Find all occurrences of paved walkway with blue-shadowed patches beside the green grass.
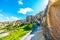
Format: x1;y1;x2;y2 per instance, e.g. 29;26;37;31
21;24;45;40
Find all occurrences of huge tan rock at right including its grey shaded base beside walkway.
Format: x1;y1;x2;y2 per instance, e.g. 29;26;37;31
45;0;60;40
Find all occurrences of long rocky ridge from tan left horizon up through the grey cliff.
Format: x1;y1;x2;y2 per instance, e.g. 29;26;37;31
0;11;44;27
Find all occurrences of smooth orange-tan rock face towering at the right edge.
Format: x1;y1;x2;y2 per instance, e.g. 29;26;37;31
48;0;60;40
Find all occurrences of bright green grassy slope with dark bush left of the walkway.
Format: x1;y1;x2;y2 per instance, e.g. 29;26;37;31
1;24;33;40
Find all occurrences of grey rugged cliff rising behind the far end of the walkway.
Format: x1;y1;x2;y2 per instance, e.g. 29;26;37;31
26;11;44;25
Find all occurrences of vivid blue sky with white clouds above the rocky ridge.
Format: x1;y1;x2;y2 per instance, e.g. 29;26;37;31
0;0;48;22
